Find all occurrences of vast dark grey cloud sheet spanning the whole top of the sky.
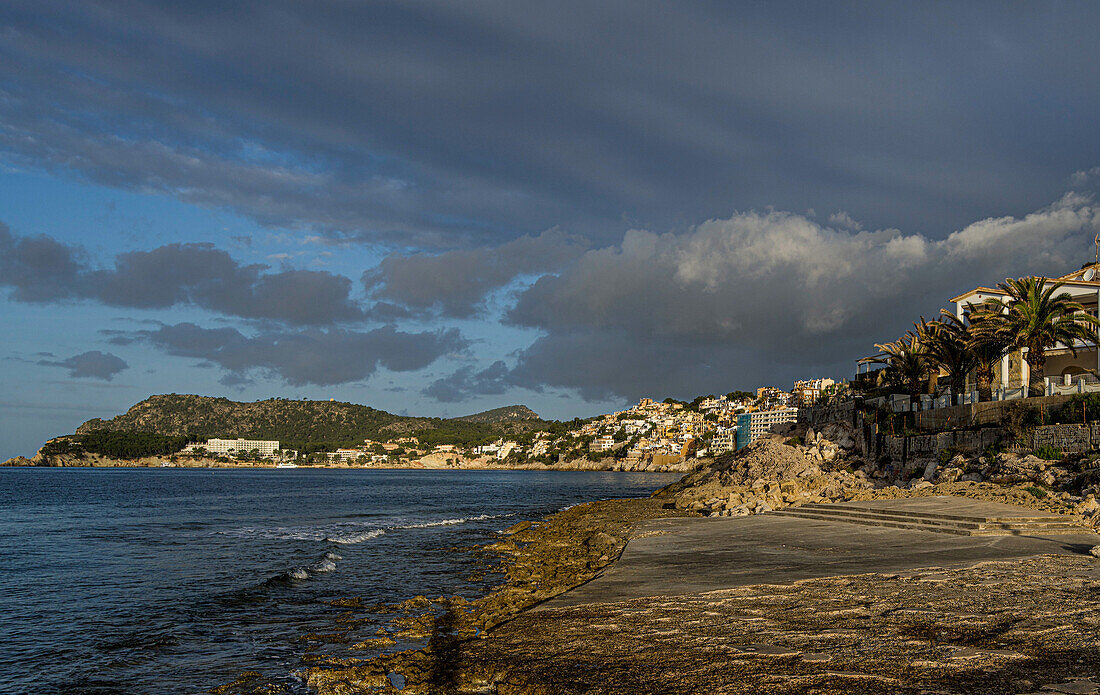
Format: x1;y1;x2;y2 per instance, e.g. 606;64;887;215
0;0;1100;245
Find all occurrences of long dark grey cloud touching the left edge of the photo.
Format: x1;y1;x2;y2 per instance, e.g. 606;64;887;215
0;224;364;326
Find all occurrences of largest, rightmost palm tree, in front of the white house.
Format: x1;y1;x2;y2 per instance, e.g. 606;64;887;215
979;277;1100;396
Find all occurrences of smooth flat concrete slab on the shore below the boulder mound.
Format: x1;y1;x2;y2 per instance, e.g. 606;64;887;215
540;497;1100;609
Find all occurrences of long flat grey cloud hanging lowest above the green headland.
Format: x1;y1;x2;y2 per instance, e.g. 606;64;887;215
134;323;469;386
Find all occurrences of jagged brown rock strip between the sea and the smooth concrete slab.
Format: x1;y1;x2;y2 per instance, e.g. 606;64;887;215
212;498;696;695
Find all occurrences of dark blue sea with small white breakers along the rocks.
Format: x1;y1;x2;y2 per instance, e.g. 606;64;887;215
0;468;679;695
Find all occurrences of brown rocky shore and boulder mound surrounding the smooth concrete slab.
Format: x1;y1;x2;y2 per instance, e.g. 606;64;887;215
236;424;1100;695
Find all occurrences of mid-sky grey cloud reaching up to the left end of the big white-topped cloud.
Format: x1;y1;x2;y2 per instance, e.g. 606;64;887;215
363;230;586;318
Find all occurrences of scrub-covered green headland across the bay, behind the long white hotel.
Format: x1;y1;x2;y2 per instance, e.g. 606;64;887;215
72;394;550;454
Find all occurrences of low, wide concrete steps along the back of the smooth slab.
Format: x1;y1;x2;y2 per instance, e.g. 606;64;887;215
770;505;1089;536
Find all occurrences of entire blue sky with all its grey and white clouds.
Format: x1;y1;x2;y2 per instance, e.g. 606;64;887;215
0;0;1100;457
